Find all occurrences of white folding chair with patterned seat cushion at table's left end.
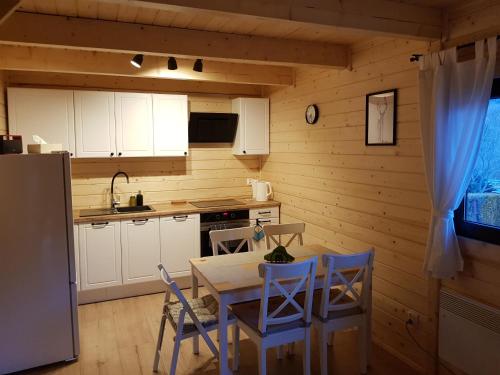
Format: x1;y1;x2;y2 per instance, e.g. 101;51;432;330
153;264;239;375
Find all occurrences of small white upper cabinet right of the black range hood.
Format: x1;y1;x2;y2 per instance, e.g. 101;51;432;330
232;98;269;155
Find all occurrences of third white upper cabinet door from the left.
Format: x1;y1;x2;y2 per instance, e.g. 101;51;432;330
115;92;154;156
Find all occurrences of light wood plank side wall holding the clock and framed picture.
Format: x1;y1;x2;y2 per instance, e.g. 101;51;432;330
261;38;436;372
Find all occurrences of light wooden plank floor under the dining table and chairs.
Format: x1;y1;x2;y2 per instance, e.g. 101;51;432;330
22;291;417;375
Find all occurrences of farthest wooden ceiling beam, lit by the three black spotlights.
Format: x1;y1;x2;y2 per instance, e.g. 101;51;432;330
0;45;294;86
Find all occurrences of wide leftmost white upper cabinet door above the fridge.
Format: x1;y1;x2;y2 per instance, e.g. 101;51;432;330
7;88;75;155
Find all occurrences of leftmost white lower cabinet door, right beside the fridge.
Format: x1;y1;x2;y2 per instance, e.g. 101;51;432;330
78;222;122;290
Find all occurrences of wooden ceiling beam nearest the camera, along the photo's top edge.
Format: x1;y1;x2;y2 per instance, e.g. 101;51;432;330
119;0;442;40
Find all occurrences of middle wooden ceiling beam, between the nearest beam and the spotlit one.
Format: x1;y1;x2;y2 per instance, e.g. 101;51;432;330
0;12;349;68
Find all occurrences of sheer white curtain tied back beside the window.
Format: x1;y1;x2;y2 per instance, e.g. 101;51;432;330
419;38;497;278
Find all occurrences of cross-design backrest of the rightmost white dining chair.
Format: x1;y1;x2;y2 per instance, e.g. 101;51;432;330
320;249;374;319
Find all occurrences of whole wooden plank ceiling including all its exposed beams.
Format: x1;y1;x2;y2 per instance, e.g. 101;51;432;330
0;0;458;85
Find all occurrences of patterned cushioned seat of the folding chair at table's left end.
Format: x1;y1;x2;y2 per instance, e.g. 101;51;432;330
167;295;234;334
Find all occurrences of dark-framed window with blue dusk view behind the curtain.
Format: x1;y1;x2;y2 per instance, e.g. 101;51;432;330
455;79;500;244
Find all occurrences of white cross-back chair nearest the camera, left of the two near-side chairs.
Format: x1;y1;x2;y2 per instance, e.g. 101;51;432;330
230;257;318;375
